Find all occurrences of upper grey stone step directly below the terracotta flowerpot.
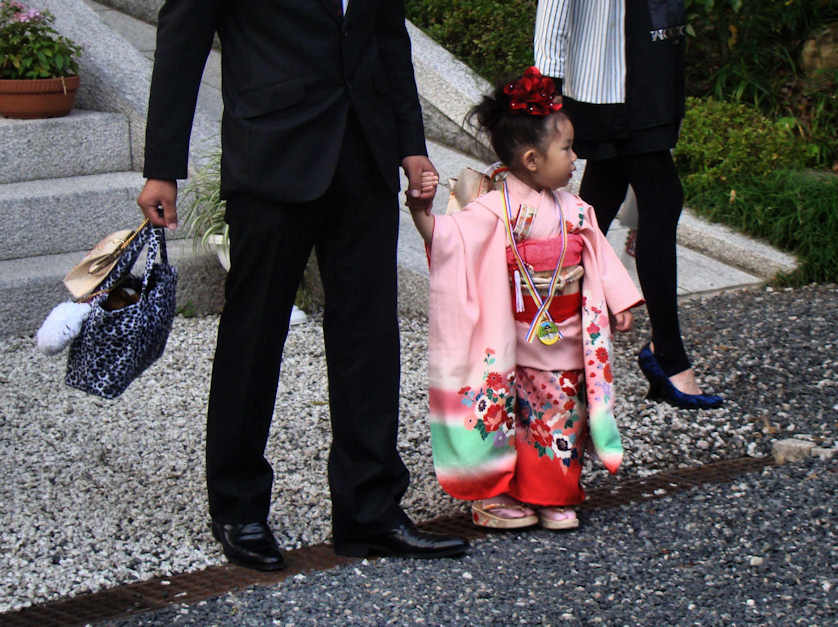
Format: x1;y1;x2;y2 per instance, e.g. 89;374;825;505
0;110;131;184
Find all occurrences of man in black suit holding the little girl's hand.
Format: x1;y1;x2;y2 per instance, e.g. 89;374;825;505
137;0;468;570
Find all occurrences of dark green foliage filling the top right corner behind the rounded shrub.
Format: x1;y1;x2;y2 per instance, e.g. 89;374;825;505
685;0;838;168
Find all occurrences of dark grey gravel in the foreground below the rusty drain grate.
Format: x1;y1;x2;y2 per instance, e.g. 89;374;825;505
108;459;838;626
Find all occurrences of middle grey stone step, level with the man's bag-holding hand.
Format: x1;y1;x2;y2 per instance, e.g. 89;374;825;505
0;172;154;260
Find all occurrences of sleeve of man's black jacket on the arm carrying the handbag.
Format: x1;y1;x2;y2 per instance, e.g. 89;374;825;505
143;0;221;180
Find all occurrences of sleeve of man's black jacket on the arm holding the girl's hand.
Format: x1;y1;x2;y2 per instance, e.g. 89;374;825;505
376;0;428;158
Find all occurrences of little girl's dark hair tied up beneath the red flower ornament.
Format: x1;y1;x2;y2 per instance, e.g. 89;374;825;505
466;74;568;170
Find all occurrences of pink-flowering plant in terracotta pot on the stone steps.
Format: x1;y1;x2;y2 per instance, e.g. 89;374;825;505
0;0;81;118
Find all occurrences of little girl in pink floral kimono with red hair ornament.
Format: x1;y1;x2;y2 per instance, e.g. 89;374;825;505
413;67;643;529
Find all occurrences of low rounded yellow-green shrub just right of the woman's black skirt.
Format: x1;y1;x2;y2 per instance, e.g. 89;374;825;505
674;98;805;186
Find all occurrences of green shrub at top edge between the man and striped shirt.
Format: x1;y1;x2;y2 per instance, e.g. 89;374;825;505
405;0;538;84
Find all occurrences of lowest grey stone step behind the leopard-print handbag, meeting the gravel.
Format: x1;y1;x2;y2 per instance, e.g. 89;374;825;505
0;239;226;337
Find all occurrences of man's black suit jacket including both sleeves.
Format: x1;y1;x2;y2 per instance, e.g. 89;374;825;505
143;0;427;202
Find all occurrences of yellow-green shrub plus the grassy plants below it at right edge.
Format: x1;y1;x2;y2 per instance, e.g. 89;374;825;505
674;98;838;284
